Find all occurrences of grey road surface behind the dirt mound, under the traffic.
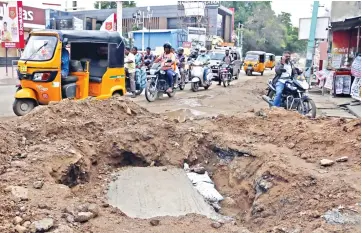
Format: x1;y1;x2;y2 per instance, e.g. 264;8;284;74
0;71;273;117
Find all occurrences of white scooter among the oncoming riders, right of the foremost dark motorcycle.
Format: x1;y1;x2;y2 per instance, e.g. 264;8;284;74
191;61;213;92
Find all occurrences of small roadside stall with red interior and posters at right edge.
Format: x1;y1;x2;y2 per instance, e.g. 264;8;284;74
317;16;361;100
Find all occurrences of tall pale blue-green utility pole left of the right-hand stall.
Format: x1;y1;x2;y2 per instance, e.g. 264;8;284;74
305;1;319;84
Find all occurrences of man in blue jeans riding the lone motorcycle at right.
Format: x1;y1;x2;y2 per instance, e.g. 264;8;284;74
273;51;296;107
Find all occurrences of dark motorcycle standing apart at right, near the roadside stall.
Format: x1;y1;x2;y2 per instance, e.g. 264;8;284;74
262;68;317;118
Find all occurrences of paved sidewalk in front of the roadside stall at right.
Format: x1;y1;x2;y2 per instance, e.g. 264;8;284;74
309;90;361;118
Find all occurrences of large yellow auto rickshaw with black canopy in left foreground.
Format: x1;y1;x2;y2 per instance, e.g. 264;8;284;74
13;30;126;116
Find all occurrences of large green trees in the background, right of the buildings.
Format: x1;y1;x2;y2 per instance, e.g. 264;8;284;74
223;1;307;54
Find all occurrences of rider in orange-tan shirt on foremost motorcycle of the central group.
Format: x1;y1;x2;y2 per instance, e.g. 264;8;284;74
155;43;176;93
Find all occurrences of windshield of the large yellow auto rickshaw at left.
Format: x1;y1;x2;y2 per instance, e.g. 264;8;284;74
20;36;58;61
